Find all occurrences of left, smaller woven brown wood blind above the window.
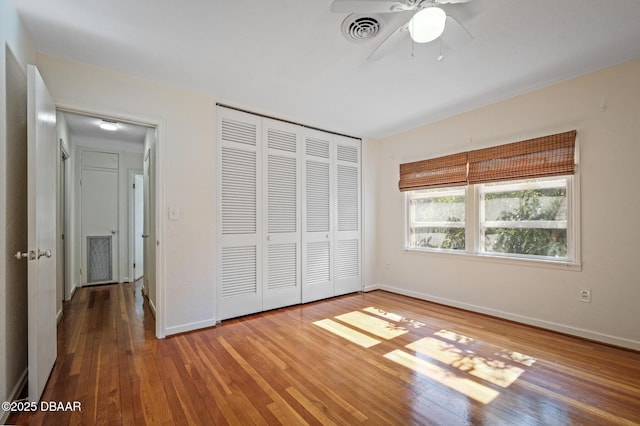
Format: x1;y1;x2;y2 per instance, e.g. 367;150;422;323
398;152;467;191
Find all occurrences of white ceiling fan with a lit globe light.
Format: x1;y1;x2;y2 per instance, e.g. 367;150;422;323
331;0;473;61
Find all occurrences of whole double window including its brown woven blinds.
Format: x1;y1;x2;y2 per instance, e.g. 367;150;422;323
399;131;578;264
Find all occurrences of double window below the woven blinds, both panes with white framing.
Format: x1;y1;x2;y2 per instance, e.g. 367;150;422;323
405;176;575;262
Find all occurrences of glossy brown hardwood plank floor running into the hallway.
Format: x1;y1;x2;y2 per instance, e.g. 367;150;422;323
9;284;640;425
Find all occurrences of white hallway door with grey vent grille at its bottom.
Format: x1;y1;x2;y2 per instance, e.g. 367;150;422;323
80;169;118;285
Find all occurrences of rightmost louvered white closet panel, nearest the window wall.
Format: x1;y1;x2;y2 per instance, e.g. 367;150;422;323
334;136;362;295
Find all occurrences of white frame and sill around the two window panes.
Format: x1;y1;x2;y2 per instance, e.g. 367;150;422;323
403;171;581;270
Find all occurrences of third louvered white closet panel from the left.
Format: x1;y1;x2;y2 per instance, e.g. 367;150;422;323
301;129;335;302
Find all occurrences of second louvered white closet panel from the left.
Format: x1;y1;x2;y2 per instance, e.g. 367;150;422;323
262;119;301;310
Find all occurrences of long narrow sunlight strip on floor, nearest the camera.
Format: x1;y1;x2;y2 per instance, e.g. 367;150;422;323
384;349;500;404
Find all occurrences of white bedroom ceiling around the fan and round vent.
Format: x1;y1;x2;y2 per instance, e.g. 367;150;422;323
13;0;640;138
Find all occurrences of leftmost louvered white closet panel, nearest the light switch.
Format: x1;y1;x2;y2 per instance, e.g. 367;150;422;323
218;108;262;320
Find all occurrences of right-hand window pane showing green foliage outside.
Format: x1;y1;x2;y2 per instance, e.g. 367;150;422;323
480;178;567;258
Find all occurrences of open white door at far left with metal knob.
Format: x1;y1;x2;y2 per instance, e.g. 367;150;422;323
26;65;57;402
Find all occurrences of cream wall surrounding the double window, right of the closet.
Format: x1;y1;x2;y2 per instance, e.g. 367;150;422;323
377;60;640;349
